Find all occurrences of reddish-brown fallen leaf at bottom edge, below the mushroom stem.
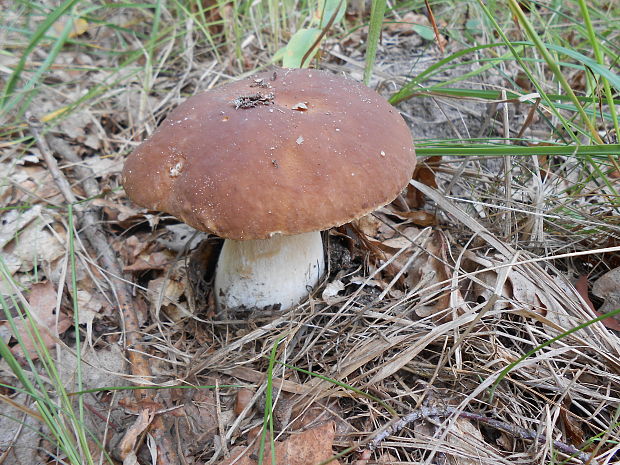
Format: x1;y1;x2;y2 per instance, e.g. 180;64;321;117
219;422;340;465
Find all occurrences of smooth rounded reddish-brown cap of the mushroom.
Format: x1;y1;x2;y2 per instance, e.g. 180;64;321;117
123;69;415;240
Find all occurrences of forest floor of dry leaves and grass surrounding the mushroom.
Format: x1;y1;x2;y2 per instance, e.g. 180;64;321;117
0;1;620;465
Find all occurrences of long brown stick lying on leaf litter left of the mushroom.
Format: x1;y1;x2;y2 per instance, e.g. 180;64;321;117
28;116;178;464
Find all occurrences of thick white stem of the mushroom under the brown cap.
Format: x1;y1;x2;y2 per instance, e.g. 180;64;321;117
215;231;325;310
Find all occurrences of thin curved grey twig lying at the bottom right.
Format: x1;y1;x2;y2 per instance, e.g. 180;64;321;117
367;407;596;465
